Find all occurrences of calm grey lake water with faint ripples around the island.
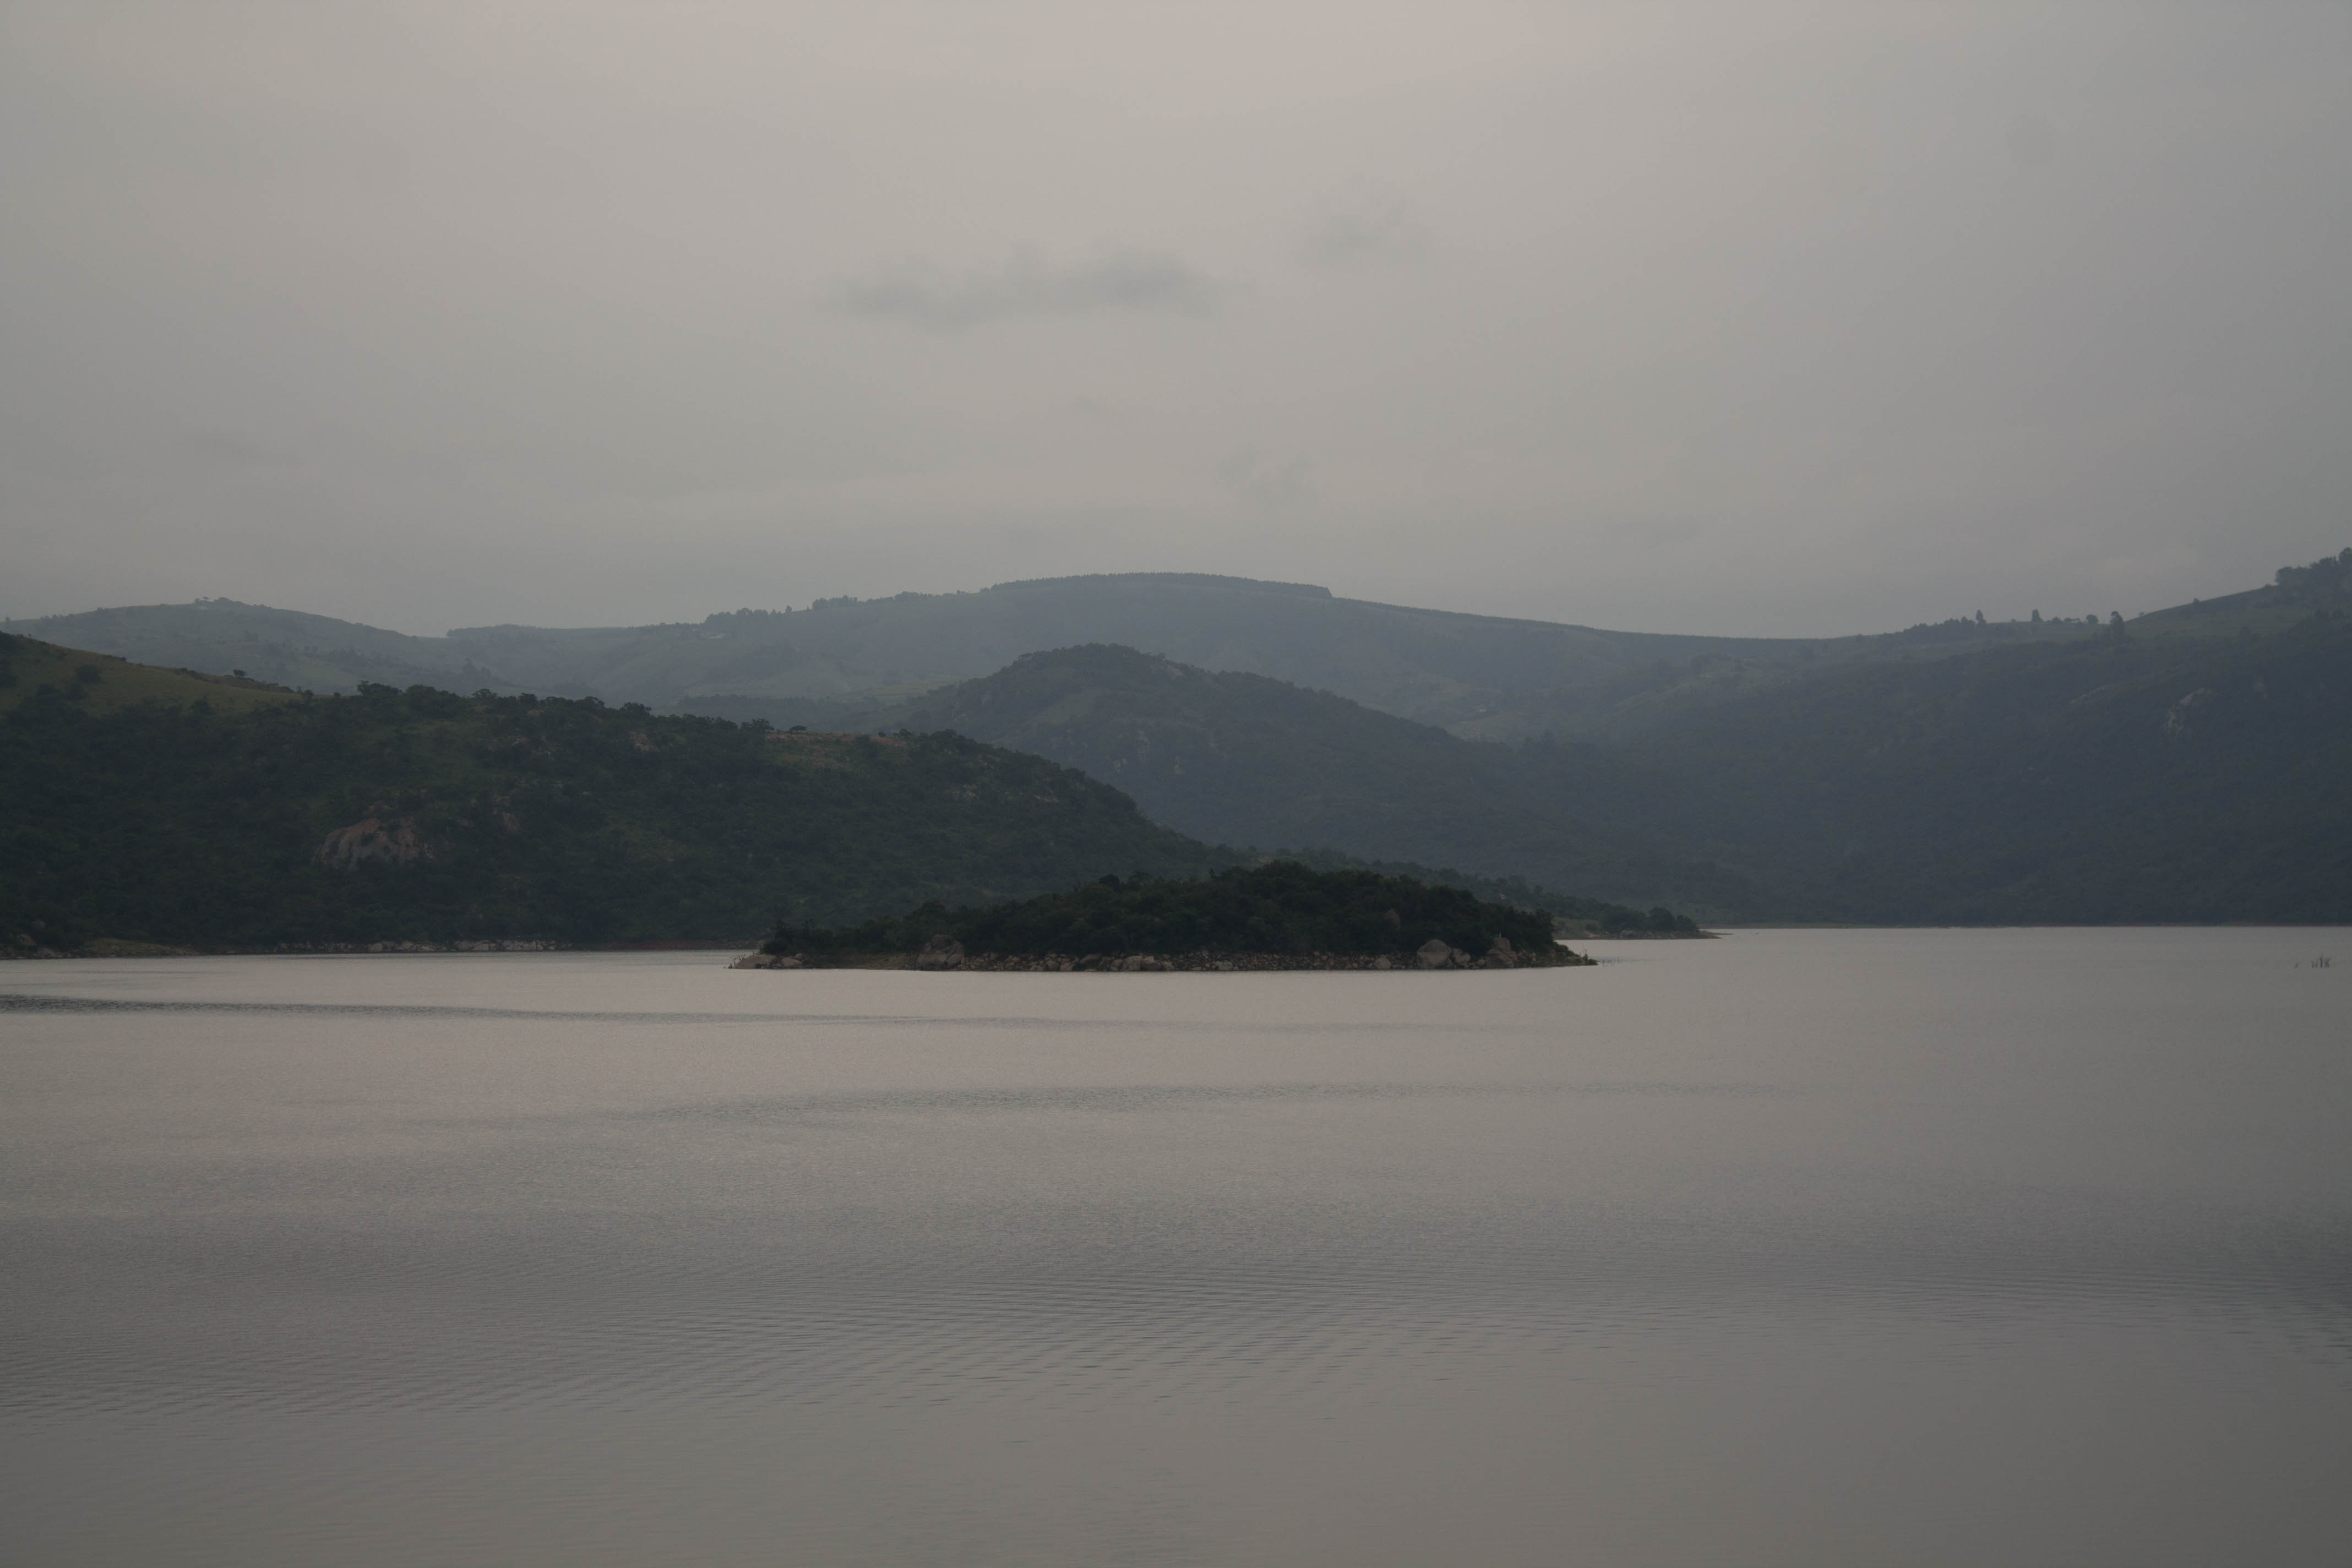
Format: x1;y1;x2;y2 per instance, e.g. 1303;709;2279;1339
0;931;2352;1568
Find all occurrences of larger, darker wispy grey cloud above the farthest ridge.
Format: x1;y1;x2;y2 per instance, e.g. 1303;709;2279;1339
825;249;1226;331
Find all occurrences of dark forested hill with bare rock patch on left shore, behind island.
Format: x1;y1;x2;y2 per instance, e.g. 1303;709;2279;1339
0;637;1233;948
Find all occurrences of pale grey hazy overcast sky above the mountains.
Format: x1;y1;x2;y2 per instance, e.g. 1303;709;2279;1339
0;0;2352;633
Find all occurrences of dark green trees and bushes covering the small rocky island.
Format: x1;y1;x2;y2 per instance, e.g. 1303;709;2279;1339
764;861;1571;964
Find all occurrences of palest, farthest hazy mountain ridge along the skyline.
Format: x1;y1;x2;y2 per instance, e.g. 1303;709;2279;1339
7;574;2145;738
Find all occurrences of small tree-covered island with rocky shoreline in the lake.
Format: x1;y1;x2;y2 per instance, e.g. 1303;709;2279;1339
734;861;1594;973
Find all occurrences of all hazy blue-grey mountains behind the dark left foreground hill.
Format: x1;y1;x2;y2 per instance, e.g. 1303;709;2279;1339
12;550;2352;924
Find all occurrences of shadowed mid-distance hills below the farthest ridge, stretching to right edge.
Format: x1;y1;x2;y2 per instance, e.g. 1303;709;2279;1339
884;574;2352;924
